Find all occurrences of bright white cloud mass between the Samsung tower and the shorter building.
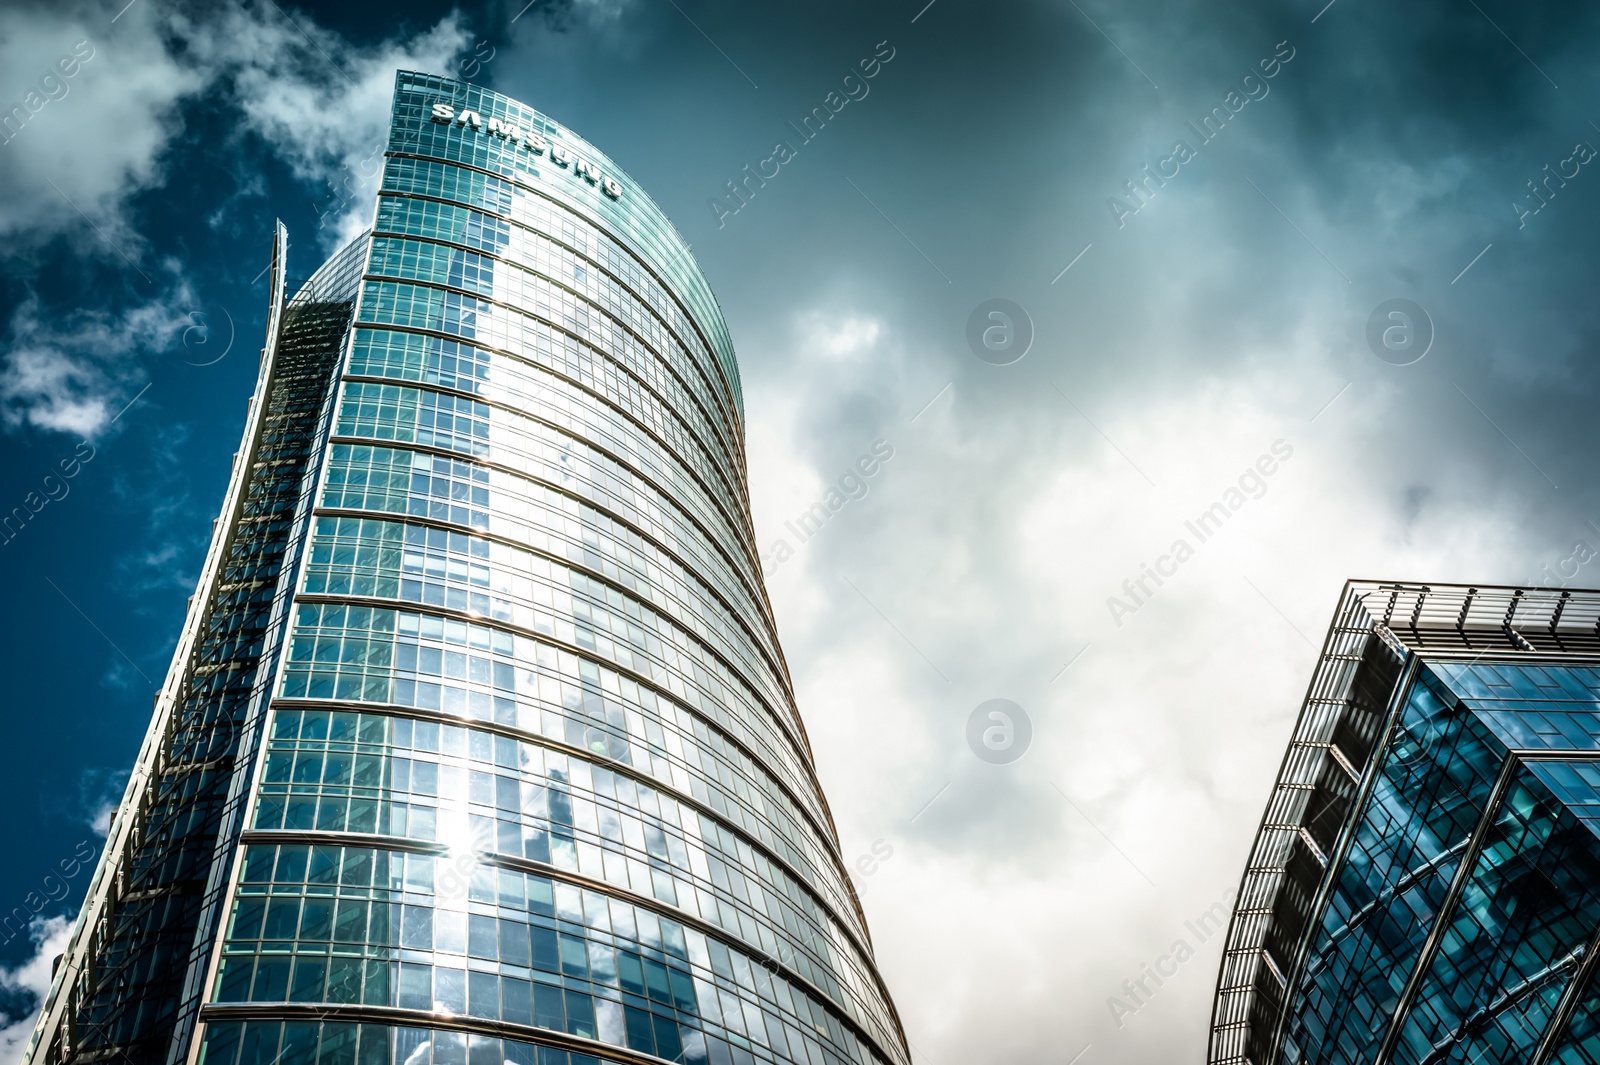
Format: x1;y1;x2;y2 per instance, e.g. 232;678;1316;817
744;284;1531;1063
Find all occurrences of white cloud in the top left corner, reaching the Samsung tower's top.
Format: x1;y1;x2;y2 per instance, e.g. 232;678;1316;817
0;3;467;251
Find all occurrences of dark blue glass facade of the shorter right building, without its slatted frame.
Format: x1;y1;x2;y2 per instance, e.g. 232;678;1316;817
1278;662;1600;1065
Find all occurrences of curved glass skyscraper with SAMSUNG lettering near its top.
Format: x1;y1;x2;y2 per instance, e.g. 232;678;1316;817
27;74;909;1065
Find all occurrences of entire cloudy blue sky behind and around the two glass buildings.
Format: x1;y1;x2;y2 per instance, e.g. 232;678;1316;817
0;0;1600;1065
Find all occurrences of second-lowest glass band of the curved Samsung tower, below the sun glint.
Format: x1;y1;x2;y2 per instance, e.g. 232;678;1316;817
216;844;866;1060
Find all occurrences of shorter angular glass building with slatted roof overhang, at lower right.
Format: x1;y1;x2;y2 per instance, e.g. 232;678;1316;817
1208;582;1600;1065
